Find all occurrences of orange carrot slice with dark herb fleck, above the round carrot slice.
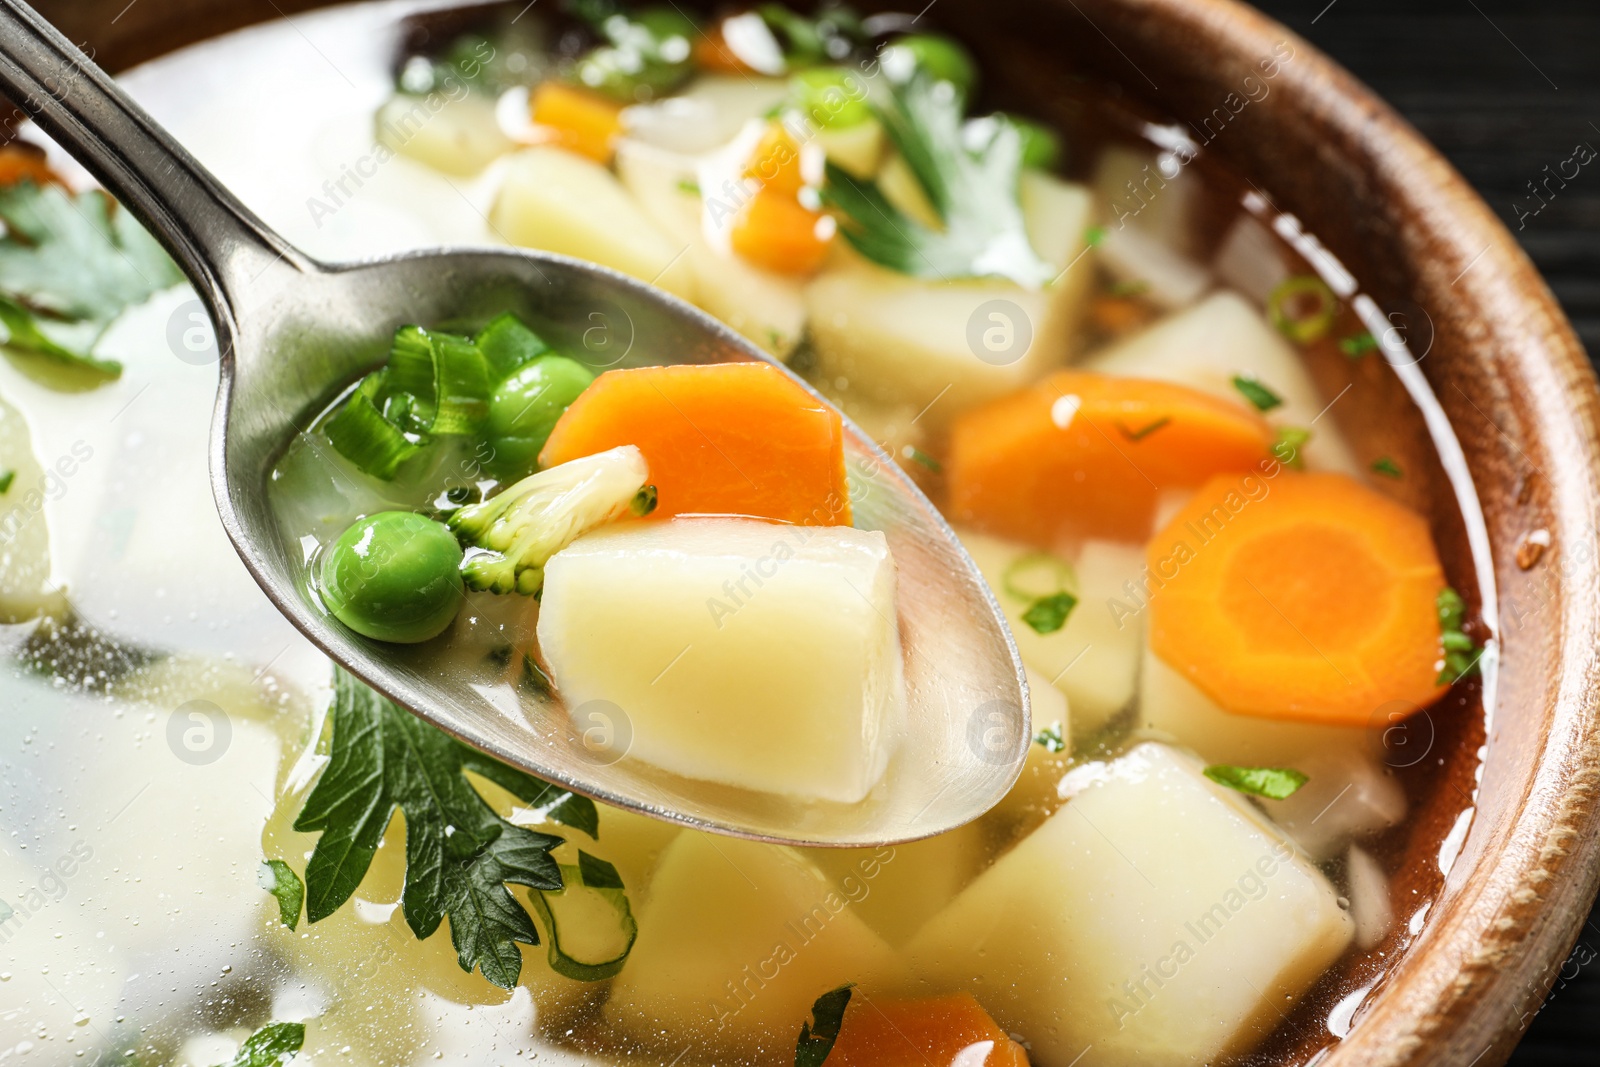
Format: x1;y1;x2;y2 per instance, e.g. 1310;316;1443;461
946;371;1272;547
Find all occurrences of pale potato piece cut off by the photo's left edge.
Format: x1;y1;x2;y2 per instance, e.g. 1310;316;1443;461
0;400;67;622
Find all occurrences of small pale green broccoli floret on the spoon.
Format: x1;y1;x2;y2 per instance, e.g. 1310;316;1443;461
446;445;654;597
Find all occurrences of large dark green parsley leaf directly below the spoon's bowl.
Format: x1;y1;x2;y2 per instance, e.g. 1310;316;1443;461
294;670;598;989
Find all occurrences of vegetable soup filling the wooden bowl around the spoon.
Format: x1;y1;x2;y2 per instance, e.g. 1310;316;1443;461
0;3;1493;1067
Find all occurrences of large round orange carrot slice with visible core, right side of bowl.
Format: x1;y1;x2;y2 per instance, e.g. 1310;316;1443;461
1149;470;1446;726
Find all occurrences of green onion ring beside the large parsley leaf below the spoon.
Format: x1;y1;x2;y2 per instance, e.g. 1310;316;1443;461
528;849;638;982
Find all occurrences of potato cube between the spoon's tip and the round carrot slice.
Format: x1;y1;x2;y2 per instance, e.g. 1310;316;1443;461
960;530;1144;734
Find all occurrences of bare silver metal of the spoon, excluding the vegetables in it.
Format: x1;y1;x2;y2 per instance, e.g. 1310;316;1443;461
0;0;1030;846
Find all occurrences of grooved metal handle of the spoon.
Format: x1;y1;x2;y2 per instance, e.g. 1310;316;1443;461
0;0;312;321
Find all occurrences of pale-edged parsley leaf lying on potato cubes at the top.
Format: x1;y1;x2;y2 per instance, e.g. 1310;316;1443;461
822;72;1056;290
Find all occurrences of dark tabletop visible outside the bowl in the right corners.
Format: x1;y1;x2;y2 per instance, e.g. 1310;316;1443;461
1254;0;1600;1067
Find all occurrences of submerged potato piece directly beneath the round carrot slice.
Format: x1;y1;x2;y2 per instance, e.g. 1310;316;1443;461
1138;652;1366;766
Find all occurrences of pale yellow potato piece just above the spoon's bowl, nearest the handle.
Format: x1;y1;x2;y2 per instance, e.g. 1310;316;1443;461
491;147;694;301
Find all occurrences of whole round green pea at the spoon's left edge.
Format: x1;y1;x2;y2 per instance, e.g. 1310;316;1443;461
317;512;462;645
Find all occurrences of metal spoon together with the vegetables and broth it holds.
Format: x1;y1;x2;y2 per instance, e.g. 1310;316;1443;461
0;0;1030;845
